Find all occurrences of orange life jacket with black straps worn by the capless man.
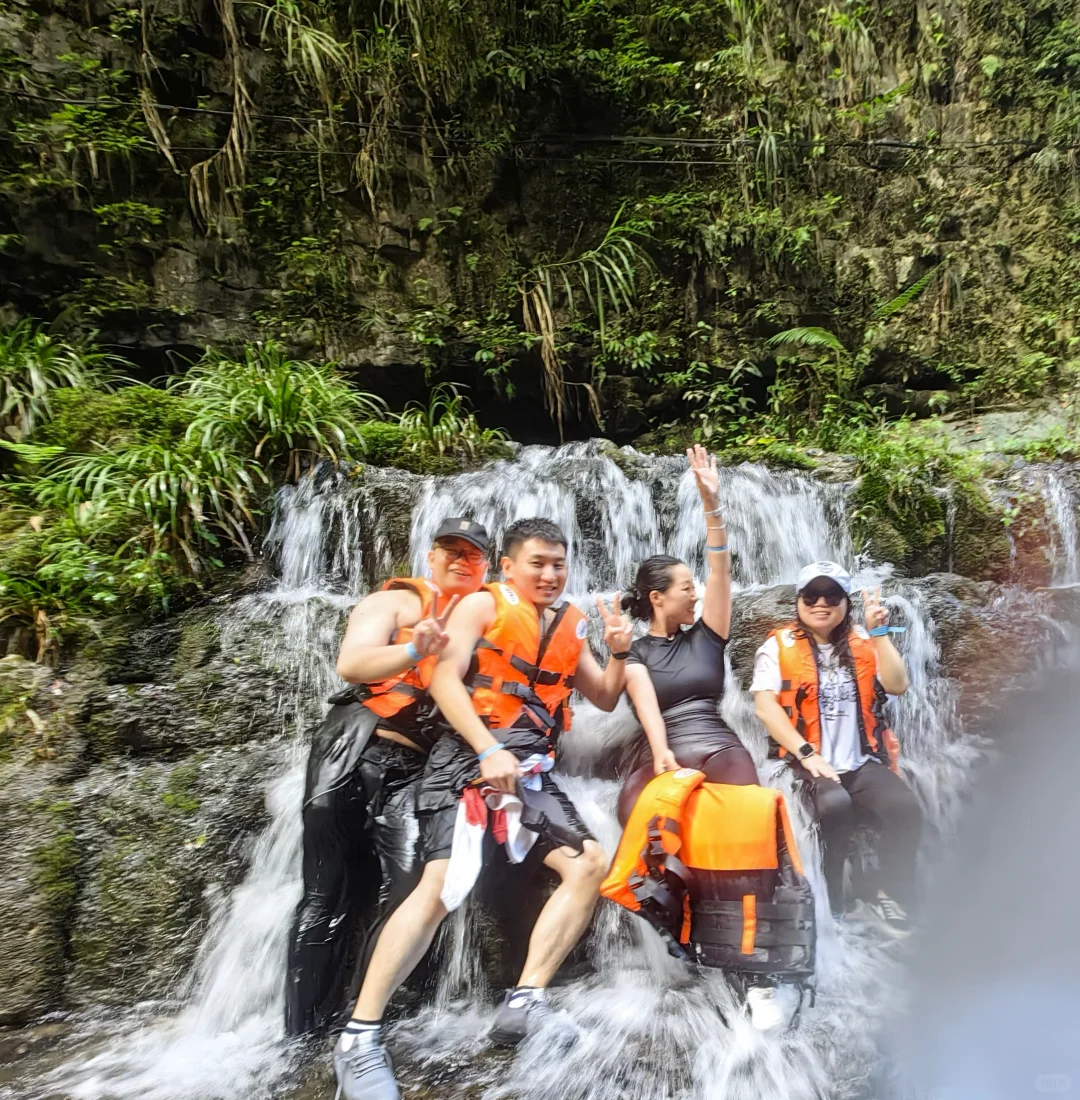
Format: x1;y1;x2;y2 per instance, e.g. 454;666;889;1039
465;582;586;736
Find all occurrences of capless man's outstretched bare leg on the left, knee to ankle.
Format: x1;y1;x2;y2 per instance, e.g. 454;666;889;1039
353;859;450;1020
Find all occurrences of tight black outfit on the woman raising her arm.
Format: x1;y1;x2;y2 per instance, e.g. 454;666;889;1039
619;619;758;822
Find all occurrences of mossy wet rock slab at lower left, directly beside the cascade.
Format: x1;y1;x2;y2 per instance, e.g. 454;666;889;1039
66;745;278;1004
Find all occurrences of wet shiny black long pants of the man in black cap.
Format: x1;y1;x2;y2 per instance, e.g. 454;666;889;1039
285;703;426;1035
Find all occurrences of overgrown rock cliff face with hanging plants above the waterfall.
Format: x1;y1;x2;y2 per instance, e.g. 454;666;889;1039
0;0;1080;441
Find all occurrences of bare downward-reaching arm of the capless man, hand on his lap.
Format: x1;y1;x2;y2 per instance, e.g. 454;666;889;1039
428;592;518;792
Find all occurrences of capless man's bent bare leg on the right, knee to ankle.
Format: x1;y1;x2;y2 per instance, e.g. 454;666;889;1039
518;840;608;988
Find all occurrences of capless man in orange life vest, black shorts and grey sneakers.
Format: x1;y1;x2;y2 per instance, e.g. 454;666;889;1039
334;519;631;1100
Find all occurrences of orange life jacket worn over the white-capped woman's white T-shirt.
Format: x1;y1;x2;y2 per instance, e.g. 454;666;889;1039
769;626;900;771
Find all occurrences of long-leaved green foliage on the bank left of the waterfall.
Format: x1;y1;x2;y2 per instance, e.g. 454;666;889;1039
0;331;502;657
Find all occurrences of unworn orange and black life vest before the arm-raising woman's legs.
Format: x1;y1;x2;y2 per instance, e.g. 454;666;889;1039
600;768;816;981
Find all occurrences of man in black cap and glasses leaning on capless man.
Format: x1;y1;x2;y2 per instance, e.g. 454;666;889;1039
285;517;491;1035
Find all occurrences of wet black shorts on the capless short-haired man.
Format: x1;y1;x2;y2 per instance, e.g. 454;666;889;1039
417;729;595;864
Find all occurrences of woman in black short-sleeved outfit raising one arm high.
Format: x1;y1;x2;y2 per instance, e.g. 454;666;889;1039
619;446;758;823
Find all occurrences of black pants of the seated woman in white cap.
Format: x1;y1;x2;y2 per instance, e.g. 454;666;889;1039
791;760;923;913
